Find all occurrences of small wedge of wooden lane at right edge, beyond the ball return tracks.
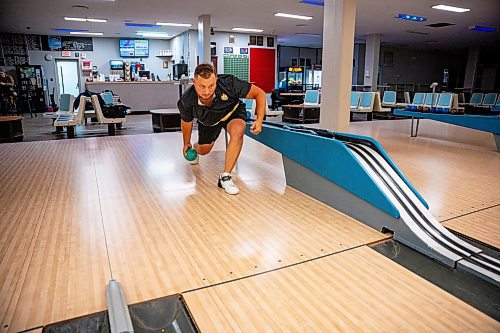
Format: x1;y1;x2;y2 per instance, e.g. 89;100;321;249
443;205;500;249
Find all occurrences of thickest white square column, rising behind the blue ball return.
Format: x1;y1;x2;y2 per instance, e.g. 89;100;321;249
319;0;356;132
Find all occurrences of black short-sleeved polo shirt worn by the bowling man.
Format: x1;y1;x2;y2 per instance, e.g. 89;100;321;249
177;74;252;126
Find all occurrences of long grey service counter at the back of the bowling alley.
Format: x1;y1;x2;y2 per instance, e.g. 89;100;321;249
85;81;190;112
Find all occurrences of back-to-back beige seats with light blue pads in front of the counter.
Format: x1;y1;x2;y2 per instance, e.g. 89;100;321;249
54;93;126;138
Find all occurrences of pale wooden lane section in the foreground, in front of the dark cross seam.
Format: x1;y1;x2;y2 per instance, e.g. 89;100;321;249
183;246;500;333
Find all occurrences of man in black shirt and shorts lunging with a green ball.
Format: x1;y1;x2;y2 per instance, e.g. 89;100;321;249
177;64;266;194
